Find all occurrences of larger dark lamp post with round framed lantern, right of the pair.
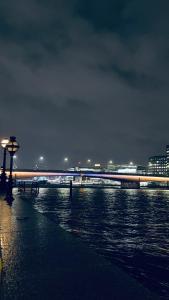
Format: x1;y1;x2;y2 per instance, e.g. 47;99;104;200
6;136;19;200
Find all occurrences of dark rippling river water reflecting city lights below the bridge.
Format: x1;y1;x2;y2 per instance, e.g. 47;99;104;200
33;188;169;299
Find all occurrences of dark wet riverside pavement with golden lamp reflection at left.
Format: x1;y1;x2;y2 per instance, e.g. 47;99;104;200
0;195;158;300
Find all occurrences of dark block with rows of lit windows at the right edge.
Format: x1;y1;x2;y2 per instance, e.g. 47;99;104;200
148;155;167;175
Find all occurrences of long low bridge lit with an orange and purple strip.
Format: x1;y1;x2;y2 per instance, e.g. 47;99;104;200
10;170;169;188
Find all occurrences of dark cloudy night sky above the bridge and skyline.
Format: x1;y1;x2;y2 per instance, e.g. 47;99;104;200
0;0;169;168
